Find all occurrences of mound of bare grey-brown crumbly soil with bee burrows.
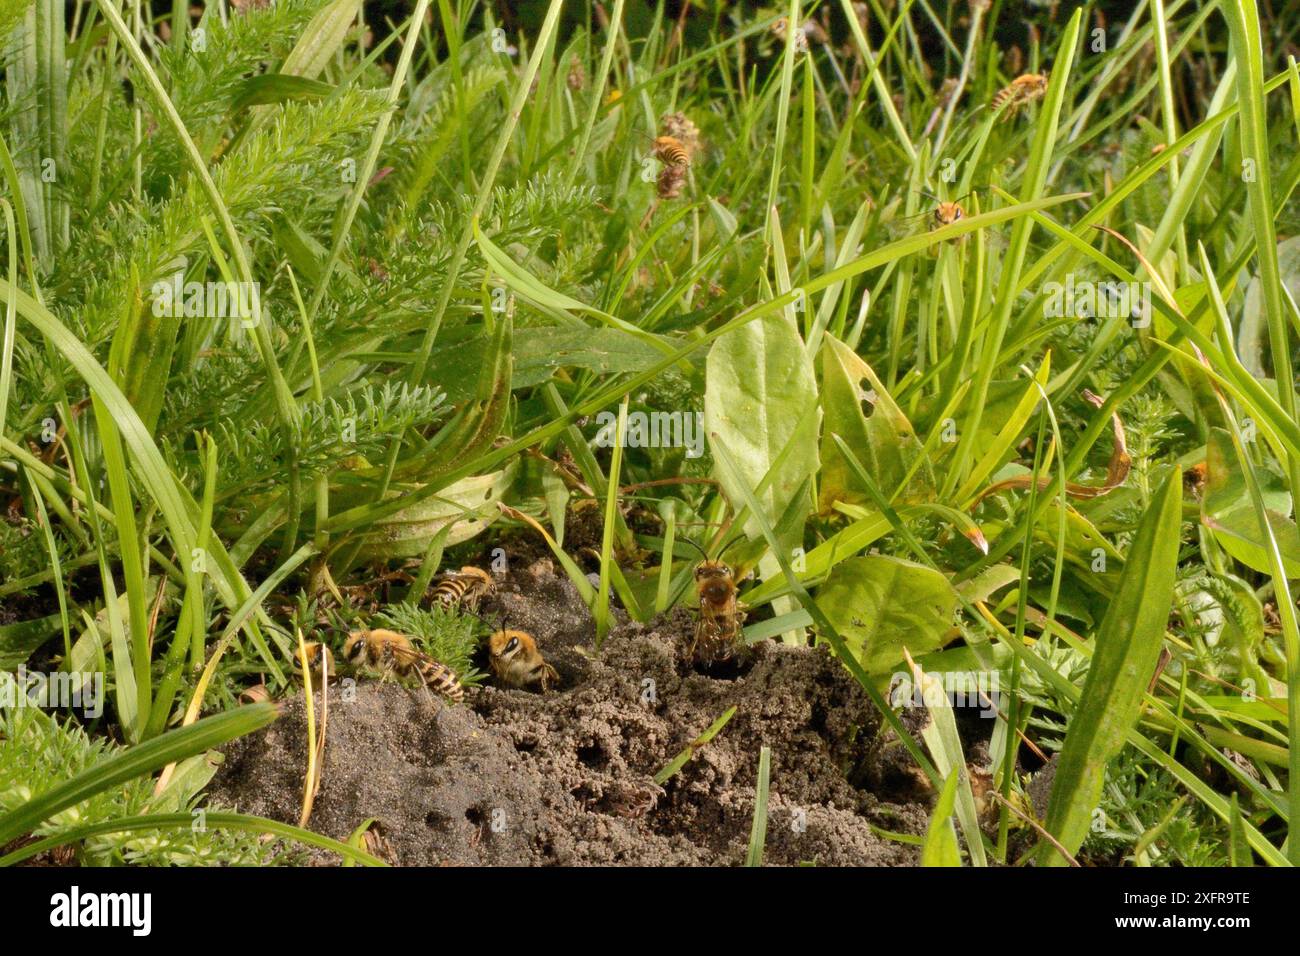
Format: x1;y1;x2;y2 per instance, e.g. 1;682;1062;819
211;559;946;866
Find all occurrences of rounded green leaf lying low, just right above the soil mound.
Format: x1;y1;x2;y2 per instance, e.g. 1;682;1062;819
816;554;957;678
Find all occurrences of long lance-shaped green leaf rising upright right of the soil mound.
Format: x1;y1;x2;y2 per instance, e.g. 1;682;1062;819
1039;468;1183;866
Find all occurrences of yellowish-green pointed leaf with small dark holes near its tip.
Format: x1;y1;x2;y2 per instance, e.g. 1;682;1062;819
818;336;935;514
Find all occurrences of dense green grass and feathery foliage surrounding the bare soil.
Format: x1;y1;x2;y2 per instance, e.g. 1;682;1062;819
0;0;1300;865
